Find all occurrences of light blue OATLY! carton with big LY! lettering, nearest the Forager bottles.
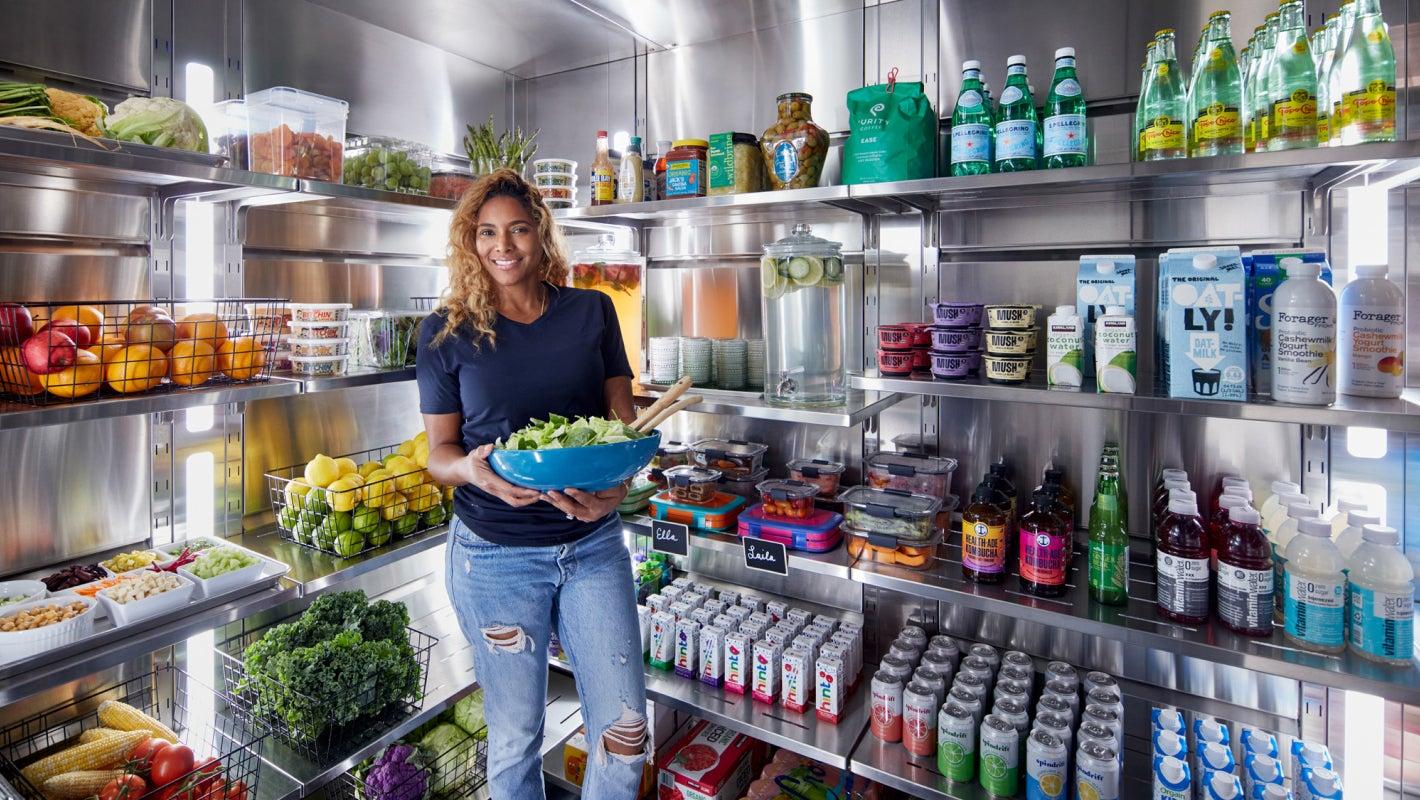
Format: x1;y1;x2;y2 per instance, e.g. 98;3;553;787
1159;247;1247;401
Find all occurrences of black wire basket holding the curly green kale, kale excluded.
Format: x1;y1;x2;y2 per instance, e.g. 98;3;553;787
216;617;439;763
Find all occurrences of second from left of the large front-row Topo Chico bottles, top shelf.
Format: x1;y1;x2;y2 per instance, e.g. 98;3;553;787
1189;11;1243;156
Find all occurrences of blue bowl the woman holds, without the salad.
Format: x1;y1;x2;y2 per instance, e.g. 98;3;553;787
488;431;660;492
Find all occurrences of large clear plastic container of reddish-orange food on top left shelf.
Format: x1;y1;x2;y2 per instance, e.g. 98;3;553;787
247;87;349;183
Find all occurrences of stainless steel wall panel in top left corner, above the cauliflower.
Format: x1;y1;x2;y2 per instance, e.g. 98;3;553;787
0;0;153;94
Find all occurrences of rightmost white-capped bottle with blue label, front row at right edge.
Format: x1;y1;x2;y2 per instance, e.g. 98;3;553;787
1346;524;1416;666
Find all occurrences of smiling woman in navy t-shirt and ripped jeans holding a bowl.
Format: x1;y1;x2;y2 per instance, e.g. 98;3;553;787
416;169;646;800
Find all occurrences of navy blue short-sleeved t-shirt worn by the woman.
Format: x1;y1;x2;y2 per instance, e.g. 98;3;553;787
415;284;630;546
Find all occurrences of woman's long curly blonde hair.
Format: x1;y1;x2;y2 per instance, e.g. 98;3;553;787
433;169;568;347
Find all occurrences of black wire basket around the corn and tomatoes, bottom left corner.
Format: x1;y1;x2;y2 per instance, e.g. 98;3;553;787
0;666;264;800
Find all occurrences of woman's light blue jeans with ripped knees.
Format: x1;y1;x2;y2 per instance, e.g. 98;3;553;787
446;516;646;800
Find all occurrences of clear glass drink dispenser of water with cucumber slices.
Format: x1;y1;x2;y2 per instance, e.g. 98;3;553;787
760;223;848;406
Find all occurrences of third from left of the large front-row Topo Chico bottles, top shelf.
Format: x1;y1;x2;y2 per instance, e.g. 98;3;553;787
1267;0;1316;151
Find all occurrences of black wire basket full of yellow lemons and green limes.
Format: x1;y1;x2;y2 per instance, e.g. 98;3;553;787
266;445;453;558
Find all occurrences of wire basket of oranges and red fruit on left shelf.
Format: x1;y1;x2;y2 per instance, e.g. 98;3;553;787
0;297;287;405
